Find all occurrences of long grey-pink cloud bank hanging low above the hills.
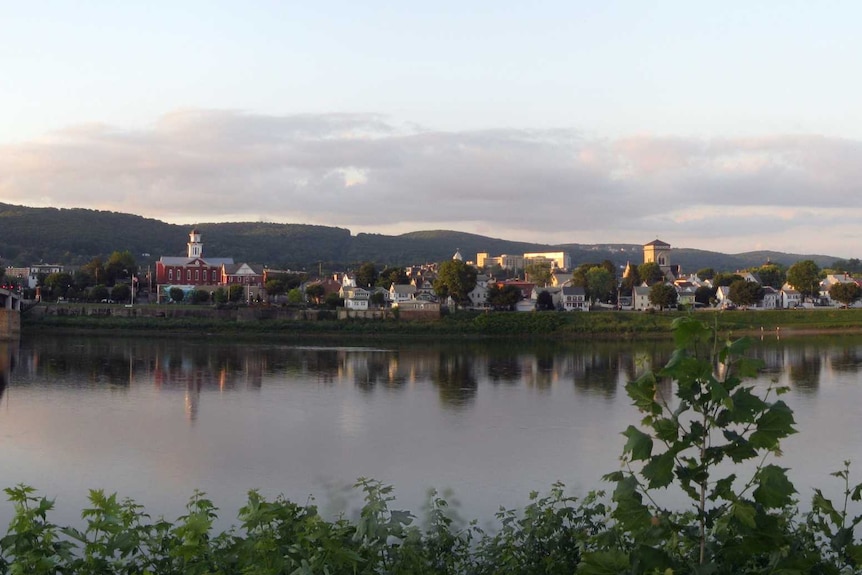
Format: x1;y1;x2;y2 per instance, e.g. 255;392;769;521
0;110;862;255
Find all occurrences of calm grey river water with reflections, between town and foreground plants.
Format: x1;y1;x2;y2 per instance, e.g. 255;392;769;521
0;336;862;533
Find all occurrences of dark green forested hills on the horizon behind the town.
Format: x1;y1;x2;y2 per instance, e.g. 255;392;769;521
0;203;838;272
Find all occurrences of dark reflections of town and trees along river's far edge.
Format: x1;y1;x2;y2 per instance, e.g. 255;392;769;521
8;337;862;408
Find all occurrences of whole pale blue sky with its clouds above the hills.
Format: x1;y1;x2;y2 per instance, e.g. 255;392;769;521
0;0;862;258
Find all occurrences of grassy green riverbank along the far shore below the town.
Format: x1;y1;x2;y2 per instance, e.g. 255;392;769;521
22;304;862;339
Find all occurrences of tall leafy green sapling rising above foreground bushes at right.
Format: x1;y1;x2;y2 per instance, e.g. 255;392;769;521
581;317;816;573
